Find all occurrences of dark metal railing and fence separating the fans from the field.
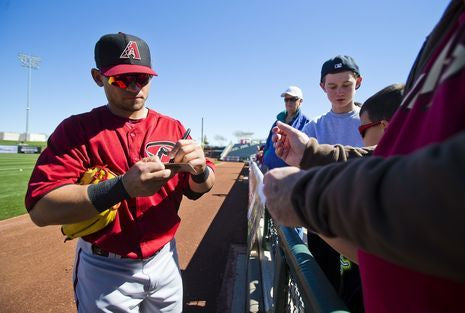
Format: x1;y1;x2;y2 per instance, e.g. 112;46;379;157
246;159;349;313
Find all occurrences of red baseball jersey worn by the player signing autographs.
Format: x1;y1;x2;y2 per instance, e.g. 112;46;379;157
26;106;214;258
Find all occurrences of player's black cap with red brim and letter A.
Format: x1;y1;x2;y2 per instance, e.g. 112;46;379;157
94;32;157;76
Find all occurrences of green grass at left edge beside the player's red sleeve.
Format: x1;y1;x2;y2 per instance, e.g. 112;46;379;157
0;153;39;220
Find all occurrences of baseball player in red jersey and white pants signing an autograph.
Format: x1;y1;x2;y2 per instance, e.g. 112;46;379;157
26;33;215;312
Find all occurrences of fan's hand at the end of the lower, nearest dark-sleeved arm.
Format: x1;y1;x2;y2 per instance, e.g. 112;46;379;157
263;167;305;226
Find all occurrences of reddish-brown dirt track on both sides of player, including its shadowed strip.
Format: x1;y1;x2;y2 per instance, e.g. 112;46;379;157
0;163;248;313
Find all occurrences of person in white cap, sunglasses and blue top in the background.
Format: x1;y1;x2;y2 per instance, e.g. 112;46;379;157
263;86;309;169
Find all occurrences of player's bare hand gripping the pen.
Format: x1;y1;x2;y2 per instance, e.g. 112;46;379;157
169;139;207;173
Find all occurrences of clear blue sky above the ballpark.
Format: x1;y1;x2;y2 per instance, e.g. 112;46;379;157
0;0;448;144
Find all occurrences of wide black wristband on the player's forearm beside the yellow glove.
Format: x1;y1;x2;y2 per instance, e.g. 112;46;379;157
87;176;130;212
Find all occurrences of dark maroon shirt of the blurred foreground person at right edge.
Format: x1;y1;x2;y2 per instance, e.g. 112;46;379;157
359;9;465;313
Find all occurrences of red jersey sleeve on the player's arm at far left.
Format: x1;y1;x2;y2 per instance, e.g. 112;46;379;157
25;117;89;211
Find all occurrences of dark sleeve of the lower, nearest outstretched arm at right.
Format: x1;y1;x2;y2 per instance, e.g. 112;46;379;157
292;131;465;281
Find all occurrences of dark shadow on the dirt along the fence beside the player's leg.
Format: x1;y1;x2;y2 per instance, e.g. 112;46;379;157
182;166;248;313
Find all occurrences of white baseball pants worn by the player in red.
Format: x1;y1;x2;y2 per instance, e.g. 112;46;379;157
73;238;183;313
